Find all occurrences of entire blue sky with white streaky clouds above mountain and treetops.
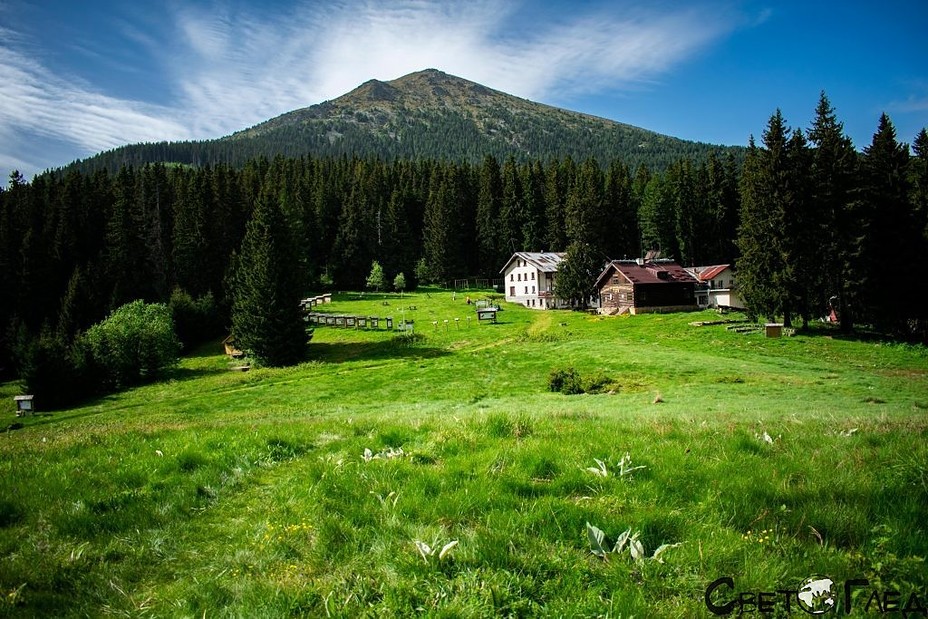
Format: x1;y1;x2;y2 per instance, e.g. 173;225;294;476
0;0;928;179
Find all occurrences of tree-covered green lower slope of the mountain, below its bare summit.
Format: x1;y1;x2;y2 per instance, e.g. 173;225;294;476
68;106;732;174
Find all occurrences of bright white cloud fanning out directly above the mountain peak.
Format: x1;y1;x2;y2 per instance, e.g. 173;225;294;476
163;0;734;137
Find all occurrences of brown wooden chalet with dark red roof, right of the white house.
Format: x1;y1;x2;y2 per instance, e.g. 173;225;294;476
596;259;699;315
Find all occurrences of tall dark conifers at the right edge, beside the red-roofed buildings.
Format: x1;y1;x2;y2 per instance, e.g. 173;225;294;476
737;94;928;341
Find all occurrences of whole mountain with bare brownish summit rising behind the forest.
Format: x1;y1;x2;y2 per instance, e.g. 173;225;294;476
67;69;743;169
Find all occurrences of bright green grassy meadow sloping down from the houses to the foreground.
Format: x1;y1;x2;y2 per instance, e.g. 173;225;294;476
0;291;928;617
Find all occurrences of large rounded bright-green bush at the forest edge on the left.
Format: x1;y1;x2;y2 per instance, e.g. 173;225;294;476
80;301;180;388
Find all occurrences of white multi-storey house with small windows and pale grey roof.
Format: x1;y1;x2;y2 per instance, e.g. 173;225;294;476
500;252;568;309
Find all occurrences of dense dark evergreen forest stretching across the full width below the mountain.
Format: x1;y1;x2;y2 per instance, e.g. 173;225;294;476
0;96;928;400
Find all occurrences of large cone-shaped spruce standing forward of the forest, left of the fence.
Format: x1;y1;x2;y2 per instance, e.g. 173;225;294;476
230;192;306;366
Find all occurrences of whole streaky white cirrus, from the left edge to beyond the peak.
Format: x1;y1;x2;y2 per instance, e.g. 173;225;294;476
0;0;738;178
